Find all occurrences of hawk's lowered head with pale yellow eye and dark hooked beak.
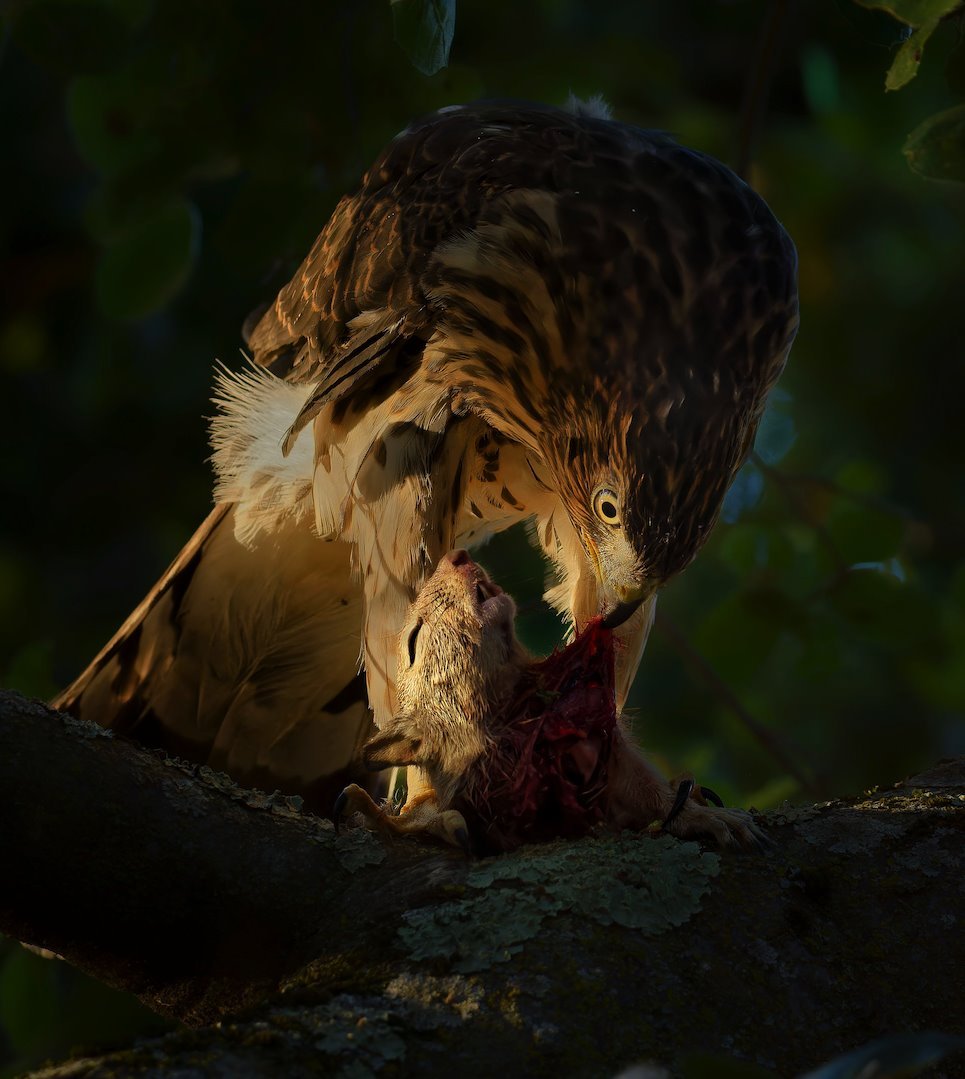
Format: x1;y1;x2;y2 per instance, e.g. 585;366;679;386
543;360;785;626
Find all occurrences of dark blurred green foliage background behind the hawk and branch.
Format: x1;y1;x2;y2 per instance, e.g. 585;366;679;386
0;0;965;1075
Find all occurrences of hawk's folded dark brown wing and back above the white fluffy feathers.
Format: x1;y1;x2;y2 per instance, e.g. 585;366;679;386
248;104;672;411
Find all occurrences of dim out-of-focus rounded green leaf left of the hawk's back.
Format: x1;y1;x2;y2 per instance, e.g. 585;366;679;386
97;200;201;318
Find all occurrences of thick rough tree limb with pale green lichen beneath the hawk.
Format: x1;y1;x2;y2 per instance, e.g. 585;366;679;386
0;693;965;1077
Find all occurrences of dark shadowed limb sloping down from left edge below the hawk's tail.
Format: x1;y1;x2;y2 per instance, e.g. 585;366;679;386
0;692;464;1023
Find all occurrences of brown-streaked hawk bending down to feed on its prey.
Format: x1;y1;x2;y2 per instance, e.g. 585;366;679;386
56;103;798;805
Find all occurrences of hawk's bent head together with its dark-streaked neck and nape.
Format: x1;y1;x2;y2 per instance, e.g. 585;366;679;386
430;109;798;625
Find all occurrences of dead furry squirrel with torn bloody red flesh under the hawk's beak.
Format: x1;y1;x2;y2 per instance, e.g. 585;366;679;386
335;550;761;853
